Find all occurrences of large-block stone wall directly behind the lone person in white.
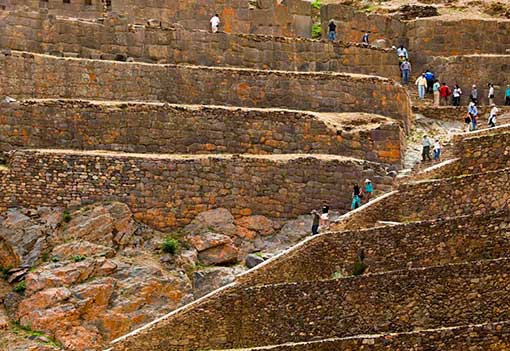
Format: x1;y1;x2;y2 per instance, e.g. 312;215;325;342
112;0;312;37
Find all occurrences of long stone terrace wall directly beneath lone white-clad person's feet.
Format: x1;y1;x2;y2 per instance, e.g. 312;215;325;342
0;11;400;80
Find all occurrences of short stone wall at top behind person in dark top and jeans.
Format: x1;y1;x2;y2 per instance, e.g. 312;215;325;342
321;4;407;46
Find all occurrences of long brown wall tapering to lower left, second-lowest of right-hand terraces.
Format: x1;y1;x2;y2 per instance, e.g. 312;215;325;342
113;259;510;351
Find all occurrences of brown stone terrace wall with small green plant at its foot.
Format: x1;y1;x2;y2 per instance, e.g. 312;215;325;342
236;211;510;286
